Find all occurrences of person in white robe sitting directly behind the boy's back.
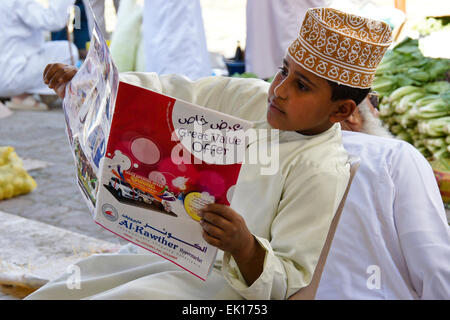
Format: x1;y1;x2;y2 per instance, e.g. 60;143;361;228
316;99;450;300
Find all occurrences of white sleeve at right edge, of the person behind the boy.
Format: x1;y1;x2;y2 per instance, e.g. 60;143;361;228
390;144;450;299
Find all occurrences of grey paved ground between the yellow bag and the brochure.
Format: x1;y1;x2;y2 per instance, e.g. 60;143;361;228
0;108;118;242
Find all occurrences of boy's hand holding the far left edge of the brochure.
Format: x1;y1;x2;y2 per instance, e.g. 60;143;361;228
43;63;78;99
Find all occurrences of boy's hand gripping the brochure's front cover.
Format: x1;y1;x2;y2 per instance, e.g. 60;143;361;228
200;203;255;262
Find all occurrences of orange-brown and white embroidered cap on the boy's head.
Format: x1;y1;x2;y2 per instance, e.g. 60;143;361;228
288;8;392;89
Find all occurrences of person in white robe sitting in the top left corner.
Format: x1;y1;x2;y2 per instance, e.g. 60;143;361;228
0;0;78;109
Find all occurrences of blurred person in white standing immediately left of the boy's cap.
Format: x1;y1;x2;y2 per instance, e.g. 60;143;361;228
245;0;329;79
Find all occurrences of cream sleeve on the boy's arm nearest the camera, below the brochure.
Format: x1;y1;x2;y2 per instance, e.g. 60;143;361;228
223;165;349;300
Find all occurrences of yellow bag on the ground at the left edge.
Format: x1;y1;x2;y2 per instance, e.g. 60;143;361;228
0;147;37;200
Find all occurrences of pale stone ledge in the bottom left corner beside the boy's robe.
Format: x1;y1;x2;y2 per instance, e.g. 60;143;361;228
0;211;120;299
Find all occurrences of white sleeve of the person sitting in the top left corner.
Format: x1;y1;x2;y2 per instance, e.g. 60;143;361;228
16;0;75;31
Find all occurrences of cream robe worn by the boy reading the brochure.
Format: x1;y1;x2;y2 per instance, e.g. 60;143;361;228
25;74;350;299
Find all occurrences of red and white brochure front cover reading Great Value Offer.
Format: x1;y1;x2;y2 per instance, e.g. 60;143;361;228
95;82;252;280
